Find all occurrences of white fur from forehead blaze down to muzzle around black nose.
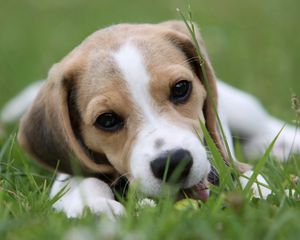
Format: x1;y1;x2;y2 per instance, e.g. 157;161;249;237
114;42;210;195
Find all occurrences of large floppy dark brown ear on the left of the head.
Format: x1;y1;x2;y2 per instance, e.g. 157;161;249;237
18;64;113;173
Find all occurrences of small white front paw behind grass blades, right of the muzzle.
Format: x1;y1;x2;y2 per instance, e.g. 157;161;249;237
240;170;272;199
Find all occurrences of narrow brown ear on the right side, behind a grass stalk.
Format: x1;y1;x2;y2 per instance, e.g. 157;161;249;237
160;21;229;164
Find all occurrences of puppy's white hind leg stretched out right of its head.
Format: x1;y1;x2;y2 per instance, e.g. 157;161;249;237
218;81;300;160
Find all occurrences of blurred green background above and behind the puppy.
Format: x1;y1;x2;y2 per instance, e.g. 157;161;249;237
0;0;300;121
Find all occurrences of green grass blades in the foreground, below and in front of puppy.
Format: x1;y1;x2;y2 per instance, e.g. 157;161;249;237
0;129;300;239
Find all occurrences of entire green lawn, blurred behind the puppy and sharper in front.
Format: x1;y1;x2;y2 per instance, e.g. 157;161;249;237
0;0;300;239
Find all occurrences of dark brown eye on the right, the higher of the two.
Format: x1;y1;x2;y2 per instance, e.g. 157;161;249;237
170;80;192;104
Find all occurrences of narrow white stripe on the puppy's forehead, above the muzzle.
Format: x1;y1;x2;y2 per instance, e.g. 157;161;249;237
113;42;155;121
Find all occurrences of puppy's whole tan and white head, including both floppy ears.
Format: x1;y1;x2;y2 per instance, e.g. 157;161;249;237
19;21;227;199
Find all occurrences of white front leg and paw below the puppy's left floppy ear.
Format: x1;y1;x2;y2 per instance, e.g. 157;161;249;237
50;174;125;219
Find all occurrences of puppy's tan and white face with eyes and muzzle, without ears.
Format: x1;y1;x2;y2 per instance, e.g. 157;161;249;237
78;38;210;194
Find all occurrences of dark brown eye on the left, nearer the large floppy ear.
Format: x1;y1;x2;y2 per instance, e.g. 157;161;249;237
95;112;124;132
